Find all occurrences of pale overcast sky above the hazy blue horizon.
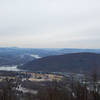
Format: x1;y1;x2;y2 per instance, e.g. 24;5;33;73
0;0;100;48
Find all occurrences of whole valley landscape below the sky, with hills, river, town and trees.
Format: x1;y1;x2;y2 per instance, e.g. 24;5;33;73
0;48;100;100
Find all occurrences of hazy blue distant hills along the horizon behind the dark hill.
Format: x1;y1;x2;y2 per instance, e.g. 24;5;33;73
0;47;100;66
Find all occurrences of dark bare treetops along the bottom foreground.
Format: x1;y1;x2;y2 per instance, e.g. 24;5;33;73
0;72;100;100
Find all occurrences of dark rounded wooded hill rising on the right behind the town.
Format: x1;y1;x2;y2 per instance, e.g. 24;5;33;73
20;53;100;72
